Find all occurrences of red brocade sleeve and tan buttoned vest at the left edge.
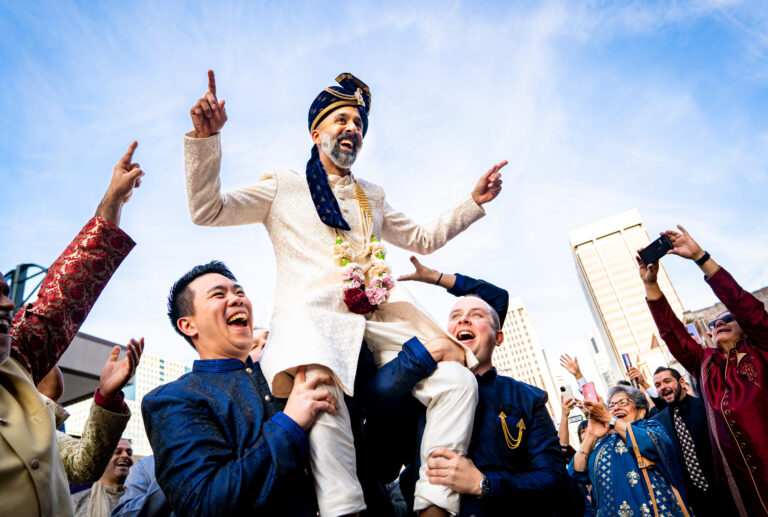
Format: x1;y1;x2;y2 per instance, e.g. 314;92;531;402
0;217;134;517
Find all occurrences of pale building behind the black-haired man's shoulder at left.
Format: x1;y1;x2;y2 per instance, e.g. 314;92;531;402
66;352;189;456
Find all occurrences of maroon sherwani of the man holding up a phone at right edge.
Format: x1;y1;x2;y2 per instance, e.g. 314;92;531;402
648;268;768;517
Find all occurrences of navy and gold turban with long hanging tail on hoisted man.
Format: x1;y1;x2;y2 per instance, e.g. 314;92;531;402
307;74;371;231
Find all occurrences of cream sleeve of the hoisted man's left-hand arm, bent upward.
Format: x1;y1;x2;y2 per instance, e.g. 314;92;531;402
184;133;277;226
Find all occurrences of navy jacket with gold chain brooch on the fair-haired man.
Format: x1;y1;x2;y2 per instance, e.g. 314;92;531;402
377;275;573;517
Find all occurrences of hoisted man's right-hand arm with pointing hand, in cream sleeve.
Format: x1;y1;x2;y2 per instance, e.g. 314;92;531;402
381;161;507;255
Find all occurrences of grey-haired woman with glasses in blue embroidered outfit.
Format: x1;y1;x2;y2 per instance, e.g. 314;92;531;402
568;385;689;517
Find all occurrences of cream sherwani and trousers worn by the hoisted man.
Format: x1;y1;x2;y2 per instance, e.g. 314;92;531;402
184;134;485;515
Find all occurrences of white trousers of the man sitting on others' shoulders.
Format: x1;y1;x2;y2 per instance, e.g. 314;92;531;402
307;286;478;517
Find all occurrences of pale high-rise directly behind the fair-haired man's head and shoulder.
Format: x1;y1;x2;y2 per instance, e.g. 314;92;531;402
493;298;560;421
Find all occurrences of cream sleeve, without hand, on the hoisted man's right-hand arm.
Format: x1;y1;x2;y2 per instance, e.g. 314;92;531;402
381;196;485;255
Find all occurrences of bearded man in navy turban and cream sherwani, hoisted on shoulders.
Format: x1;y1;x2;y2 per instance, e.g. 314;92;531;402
184;70;507;516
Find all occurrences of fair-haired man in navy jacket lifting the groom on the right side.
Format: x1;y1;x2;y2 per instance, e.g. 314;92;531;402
388;257;575;516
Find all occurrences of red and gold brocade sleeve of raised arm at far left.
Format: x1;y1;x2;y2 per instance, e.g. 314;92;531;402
10;217;135;384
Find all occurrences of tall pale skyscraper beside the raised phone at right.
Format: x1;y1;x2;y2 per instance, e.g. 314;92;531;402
569;210;683;381
